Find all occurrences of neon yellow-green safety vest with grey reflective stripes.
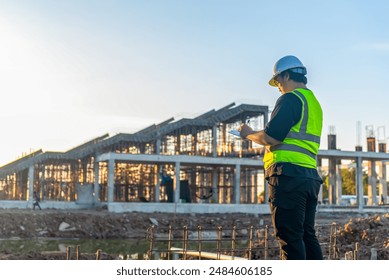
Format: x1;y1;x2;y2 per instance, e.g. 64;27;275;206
263;88;323;169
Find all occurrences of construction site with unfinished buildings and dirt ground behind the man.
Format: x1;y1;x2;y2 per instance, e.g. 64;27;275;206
0;103;389;259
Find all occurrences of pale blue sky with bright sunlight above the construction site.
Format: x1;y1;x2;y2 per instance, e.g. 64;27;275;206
0;0;389;165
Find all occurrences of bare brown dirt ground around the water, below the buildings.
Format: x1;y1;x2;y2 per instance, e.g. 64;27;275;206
0;209;389;260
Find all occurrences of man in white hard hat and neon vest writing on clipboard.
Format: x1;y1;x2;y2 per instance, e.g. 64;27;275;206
239;55;323;260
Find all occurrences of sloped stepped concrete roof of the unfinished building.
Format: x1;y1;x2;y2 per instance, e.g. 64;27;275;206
0;103;269;178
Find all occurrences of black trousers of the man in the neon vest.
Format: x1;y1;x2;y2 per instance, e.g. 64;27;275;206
268;175;323;260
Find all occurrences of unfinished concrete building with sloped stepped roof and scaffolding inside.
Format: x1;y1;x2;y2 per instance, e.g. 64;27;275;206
0;103;268;211
